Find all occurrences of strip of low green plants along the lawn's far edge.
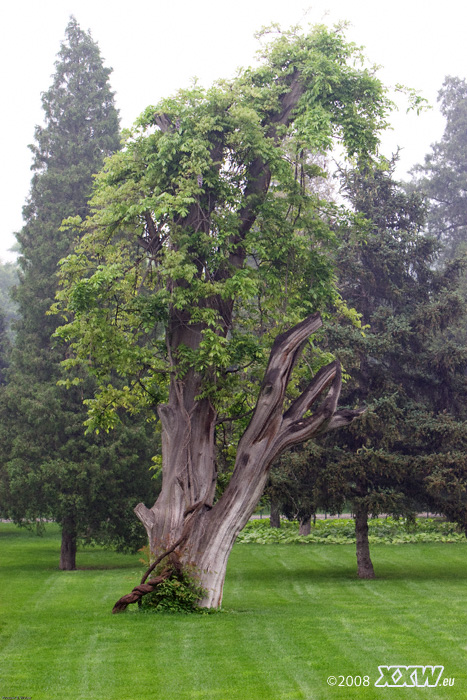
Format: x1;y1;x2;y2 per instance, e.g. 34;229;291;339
237;517;466;544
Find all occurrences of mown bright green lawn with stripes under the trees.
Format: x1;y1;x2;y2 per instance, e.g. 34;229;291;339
0;524;467;700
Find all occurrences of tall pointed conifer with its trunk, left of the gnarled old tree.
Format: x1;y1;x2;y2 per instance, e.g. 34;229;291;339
0;18;158;569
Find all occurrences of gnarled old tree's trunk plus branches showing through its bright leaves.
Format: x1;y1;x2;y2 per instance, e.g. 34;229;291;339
116;69;368;610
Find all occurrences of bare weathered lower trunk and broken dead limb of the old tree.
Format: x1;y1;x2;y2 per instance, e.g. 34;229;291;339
131;314;364;608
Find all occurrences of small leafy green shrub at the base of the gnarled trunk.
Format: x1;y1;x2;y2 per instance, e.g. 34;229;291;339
141;568;206;614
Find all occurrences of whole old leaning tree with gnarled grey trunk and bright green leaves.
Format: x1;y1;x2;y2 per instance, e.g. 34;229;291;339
56;27;390;609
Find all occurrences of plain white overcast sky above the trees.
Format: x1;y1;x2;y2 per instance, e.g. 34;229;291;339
0;0;467;260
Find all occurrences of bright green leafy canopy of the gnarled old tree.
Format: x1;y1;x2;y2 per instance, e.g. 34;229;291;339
55;27;391;428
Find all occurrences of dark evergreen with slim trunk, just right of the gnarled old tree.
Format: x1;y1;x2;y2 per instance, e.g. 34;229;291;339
273;162;467;578
